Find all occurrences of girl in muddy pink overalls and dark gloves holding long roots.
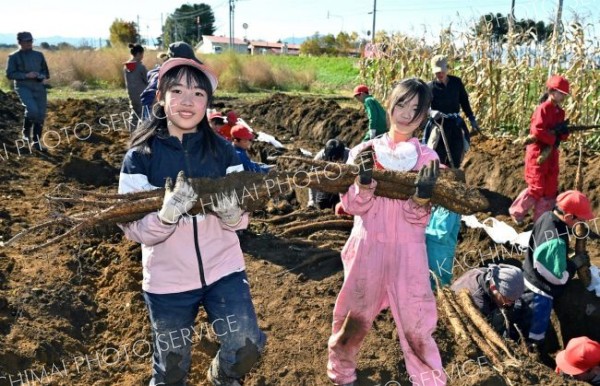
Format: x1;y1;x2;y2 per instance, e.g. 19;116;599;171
327;78;446;386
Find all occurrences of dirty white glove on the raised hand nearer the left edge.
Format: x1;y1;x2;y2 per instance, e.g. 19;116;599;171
158;171;198;224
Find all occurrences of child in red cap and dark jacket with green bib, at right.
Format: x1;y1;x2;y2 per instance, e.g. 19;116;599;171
523;190;594;350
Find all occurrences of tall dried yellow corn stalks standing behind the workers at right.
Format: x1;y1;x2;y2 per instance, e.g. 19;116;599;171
361;23;600;147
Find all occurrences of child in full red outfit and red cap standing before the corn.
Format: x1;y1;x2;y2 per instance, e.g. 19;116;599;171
509;75;569;225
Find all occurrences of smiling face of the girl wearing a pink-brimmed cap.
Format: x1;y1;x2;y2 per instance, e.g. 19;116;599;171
159;76;208;139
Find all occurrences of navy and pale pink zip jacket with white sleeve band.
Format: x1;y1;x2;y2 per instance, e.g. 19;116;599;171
119;132;248;294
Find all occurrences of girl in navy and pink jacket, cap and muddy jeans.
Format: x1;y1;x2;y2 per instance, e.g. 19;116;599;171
119;58;265;386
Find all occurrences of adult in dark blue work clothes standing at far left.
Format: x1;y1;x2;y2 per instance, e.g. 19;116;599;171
6;32;50;150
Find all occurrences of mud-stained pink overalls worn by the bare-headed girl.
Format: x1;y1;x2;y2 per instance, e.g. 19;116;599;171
327;135;446;386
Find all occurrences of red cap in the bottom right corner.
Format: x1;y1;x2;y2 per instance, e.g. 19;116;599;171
556;336;600;375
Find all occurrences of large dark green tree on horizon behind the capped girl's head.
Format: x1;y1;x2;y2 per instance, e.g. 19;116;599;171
163;3;216;45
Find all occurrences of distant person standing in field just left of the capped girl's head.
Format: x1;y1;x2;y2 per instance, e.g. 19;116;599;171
123;44;148;131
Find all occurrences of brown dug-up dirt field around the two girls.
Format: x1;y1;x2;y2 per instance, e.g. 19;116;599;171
0;92;600;386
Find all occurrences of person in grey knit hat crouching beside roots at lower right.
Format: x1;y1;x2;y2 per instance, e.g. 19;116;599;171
450;264;525;337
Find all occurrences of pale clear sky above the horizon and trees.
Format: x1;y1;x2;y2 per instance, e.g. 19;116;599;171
0;0;600;45
